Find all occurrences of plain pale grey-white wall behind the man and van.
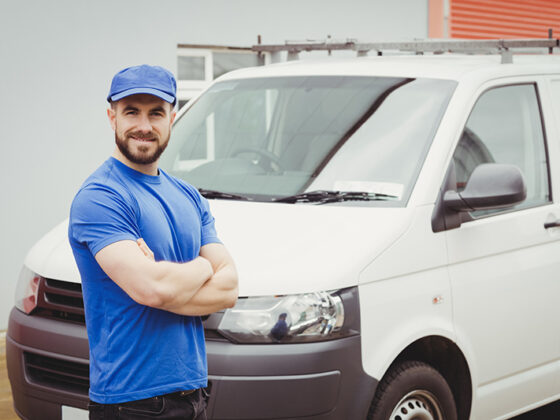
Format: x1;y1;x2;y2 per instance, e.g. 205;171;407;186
0;0;428;330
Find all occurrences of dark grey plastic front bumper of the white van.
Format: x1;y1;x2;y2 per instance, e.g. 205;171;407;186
6;309;377;420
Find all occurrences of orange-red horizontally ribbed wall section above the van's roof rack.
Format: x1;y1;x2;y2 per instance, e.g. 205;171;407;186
449;0;560;39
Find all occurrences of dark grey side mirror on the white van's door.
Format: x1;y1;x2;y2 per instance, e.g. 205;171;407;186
443;163;527;212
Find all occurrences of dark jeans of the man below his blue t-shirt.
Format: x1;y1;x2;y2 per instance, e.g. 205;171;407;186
88;389;208;420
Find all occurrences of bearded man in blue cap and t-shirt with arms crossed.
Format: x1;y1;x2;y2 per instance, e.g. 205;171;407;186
68;65;237;420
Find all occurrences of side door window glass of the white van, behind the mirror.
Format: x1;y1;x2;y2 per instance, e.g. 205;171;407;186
453;84;551;217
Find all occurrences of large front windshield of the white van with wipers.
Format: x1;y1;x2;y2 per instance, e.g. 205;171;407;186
160;76;455;205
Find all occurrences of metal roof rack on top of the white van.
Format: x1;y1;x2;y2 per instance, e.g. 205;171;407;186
251;38;560;63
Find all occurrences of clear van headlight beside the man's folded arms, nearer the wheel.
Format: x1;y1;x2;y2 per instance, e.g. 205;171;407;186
218;292;355;343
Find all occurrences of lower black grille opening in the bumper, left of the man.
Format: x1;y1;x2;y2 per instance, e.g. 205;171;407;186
23;352;89;395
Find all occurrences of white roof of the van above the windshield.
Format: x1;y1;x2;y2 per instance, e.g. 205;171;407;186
220;54;560;81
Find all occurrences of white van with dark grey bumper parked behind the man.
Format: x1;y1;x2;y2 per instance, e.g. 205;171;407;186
7;40;560;420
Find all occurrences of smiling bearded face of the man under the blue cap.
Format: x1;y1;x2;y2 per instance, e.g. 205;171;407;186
108;94;175;165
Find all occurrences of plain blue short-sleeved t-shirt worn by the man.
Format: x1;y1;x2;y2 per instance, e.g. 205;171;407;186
68;158;219;404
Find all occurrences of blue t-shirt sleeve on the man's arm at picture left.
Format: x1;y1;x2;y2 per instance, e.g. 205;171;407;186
69;185;140;255
